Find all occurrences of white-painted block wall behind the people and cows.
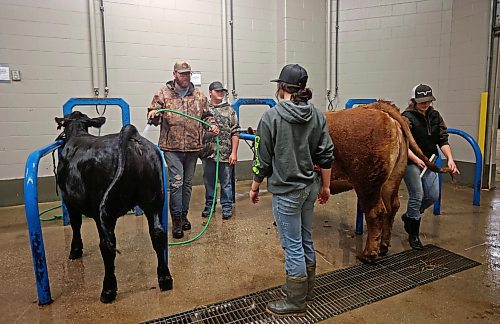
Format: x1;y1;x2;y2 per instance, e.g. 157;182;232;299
0;0;490;179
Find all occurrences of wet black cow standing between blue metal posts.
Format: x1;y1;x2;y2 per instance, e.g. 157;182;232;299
55;111;172;303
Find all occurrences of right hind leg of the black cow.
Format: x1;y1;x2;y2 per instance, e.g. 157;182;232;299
145;210;173;291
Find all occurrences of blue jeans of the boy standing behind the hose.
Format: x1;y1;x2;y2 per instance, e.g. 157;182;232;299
202;159;234;212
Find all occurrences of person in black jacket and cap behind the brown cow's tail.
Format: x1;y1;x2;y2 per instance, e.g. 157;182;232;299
401;84;460;250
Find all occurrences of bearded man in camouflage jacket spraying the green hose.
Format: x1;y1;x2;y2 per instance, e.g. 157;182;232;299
148;61;219;239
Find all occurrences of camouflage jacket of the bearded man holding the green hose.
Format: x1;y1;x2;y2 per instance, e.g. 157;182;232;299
148;80;216;152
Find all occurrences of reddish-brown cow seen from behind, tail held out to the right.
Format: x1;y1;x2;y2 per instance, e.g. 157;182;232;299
325;101;448;262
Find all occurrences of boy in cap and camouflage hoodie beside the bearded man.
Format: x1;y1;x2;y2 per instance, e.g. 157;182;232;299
200;81;240;219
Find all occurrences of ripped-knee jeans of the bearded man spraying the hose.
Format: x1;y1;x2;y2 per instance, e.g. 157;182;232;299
163;151;199;217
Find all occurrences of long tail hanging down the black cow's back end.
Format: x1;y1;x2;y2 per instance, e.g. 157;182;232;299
99;125;138;253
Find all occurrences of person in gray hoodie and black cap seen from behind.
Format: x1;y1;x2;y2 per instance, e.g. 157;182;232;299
249;64;333;316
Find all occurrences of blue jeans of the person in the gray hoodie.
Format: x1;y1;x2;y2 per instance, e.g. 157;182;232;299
273;177;320;277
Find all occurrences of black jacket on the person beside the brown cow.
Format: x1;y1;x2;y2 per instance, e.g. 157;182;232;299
403;104;448;163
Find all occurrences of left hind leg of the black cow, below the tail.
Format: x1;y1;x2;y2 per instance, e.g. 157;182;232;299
96;219;118;303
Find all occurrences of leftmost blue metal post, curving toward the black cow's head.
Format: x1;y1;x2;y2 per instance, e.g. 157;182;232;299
24;140;64;305
